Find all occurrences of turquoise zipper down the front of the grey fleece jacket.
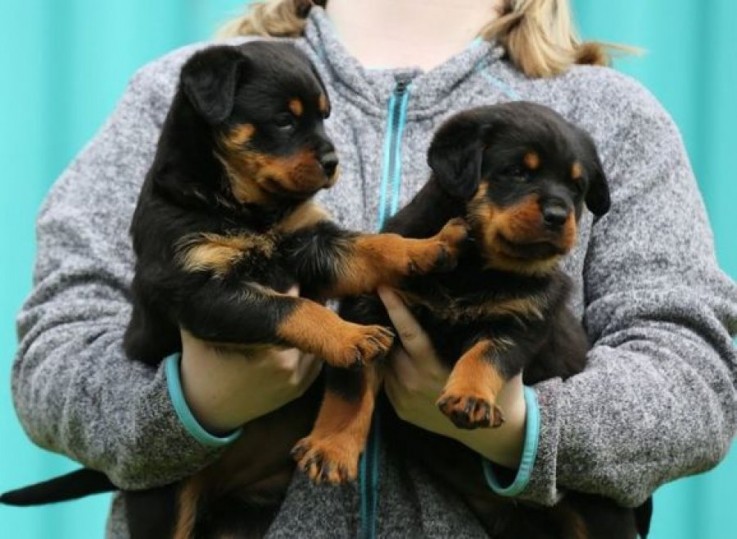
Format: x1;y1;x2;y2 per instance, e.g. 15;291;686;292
359;80;410;539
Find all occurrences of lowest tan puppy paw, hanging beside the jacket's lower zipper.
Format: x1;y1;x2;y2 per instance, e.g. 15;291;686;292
292;434;360;485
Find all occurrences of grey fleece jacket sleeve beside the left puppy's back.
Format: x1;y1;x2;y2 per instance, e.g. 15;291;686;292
12;49;233;489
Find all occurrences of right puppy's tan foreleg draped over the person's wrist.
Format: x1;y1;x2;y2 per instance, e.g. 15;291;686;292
437;338;519;429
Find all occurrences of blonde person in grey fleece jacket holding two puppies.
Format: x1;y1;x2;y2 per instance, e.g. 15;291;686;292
8;0;737;538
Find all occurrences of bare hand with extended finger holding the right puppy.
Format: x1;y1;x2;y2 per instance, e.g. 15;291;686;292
378;288;526;468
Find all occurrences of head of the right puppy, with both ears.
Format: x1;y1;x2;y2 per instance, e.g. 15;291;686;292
428;102;610;274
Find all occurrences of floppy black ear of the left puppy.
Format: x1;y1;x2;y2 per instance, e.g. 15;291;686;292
181;46;246;125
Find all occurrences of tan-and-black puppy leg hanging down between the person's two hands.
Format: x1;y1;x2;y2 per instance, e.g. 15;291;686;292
292;365;380;484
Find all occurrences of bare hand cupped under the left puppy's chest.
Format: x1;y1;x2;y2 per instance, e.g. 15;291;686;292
180;288;322;435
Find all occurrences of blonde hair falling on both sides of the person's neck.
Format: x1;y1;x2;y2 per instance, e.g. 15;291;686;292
218;0;635;77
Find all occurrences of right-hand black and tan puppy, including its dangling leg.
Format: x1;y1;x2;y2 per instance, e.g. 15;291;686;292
295;102;649;539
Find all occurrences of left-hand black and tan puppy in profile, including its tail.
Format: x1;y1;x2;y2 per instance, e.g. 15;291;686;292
2;42;466;538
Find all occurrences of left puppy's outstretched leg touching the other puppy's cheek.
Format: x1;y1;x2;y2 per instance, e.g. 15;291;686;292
283;219;467;297
